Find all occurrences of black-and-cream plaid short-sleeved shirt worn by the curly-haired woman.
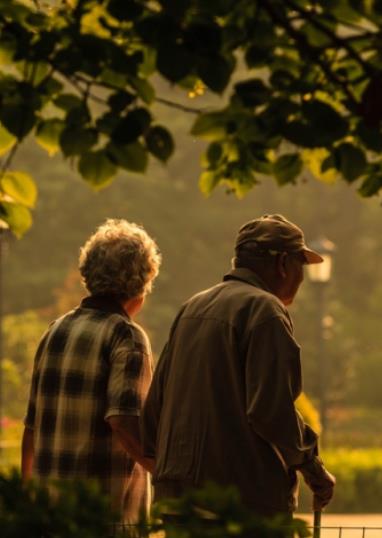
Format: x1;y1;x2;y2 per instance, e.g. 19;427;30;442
25;297;152;522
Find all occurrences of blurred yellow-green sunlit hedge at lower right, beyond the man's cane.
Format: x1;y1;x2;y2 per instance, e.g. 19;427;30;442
300;449;382;513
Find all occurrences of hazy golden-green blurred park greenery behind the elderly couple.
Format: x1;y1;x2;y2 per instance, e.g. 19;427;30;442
1;98;382;512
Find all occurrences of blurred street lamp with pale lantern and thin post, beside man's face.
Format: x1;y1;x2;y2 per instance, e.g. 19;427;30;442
307;237;335;440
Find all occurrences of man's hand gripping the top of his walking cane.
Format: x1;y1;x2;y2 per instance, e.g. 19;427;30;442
298;457;336;510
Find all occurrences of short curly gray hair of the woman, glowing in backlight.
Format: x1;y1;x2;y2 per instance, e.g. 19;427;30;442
79;219;161;299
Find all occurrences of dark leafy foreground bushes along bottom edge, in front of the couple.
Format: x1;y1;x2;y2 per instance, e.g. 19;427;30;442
0;471;309;538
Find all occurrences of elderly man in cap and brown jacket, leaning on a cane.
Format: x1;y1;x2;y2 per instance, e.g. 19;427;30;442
142;215;334;516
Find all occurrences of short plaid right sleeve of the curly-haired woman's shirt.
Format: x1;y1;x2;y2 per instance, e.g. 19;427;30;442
105;324;151;419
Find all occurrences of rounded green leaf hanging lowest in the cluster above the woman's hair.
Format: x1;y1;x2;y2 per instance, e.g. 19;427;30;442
78;150;117;190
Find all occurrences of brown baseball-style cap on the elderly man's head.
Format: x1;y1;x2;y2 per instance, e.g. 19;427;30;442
235;215;324;263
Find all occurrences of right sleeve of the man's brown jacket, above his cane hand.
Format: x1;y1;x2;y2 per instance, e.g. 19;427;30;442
245;317;317;467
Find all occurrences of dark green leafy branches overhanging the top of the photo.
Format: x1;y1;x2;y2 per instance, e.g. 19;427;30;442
0;0;382;235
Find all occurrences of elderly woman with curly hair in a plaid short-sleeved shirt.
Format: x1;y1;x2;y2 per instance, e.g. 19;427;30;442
22;219;161;523
